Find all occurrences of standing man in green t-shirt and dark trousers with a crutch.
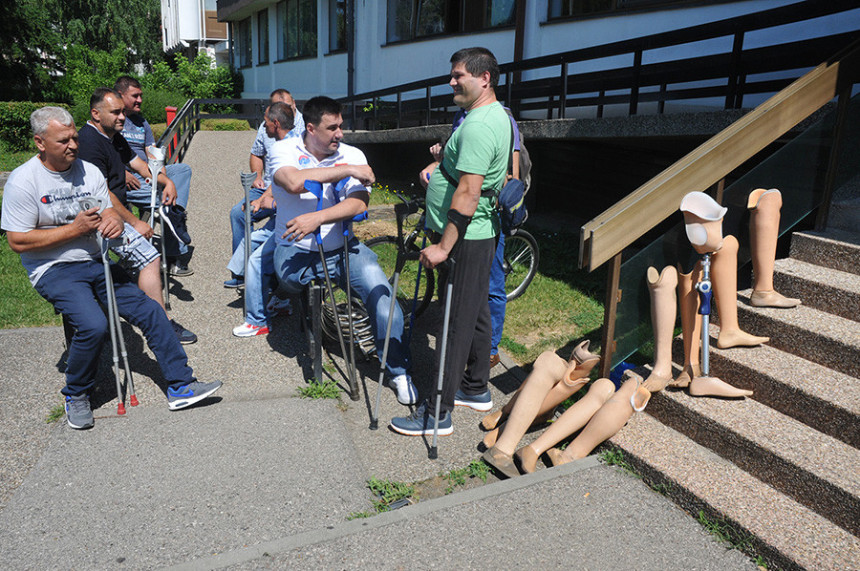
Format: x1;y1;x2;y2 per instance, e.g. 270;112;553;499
391;48;511;436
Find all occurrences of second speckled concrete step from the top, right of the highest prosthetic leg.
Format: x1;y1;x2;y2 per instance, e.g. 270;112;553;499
773;258;860;321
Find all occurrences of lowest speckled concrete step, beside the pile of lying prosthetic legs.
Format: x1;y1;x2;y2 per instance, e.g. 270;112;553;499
610;414;860;571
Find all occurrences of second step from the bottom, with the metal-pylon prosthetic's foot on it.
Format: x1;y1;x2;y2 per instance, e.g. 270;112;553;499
647;378;860;535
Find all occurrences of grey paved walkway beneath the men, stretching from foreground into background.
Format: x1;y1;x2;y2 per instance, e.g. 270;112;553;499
0;132;754;569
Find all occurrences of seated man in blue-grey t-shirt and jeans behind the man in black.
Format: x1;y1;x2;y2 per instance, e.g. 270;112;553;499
113;75;194;277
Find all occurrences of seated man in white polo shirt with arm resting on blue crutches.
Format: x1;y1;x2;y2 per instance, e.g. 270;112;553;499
271;96;418;405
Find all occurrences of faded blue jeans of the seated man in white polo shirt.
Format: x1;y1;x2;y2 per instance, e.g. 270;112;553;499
274;238;410;376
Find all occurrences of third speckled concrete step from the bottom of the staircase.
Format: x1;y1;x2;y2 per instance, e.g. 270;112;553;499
684;325;860;448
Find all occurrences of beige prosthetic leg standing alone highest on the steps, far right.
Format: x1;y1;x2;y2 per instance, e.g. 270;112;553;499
747;188;800;308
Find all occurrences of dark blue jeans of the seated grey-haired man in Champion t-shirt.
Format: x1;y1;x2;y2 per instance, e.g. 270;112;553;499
35;261;194;396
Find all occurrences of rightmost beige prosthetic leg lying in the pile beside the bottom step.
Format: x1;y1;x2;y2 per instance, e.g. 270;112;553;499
547;378;642;466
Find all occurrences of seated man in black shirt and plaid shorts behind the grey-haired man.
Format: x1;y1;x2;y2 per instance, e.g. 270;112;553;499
78;87;197;344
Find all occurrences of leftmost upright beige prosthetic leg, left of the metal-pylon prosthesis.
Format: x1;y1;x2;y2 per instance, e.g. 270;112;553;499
642;266;678;393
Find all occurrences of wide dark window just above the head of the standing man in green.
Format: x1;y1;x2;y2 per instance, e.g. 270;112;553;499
386;0;516;42
